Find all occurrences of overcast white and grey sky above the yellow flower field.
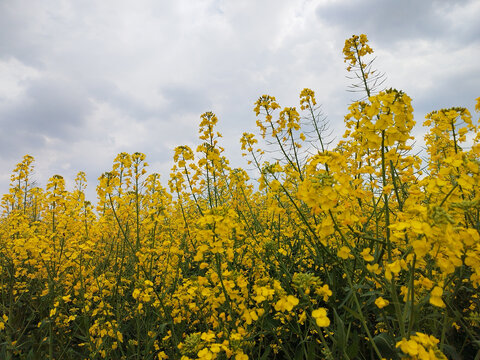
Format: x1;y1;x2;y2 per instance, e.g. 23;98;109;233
0;0;480;200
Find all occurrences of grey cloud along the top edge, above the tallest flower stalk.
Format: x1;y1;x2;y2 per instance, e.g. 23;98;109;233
316;0;480;47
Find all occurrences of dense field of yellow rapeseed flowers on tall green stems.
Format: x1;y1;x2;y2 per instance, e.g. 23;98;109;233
0;35;480;360
